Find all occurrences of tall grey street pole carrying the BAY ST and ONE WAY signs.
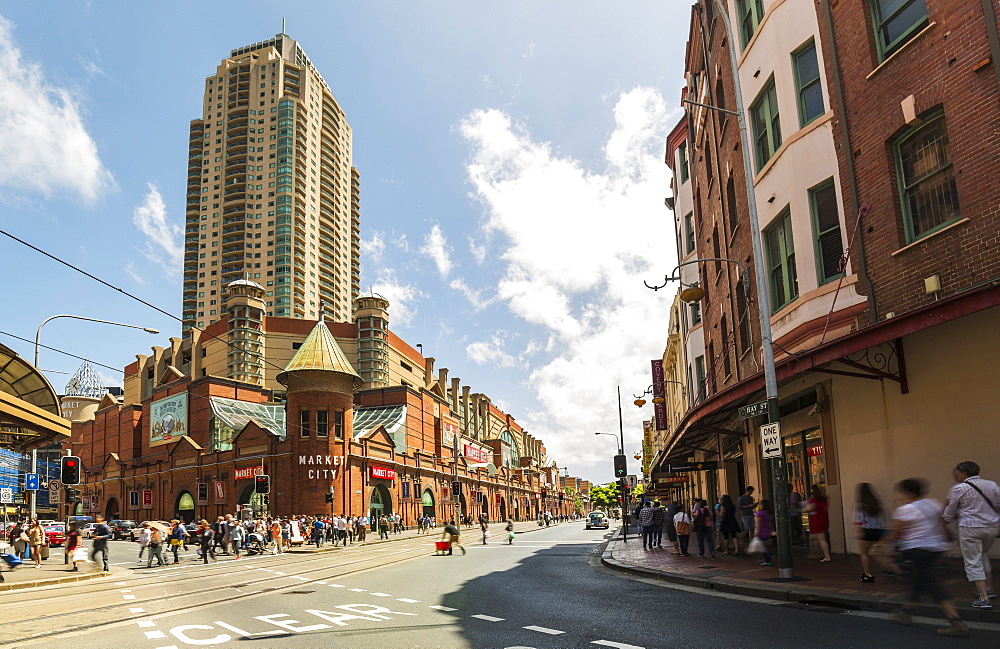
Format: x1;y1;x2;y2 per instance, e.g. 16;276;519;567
647;0;794;579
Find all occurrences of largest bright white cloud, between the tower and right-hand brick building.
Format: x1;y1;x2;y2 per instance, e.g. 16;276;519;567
460;88;676;466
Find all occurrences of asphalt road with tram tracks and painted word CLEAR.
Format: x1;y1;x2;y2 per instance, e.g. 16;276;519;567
0;523;1000;649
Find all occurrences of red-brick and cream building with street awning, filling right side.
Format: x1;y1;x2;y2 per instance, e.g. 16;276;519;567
652;0;1000;550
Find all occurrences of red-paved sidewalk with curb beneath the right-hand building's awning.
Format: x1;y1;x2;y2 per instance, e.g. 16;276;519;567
601;528;1000;623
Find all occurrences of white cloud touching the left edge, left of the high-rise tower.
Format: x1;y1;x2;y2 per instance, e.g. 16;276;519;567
0;16;114;202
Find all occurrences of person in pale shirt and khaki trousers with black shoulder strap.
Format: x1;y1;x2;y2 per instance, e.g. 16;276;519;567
944;461;1000;611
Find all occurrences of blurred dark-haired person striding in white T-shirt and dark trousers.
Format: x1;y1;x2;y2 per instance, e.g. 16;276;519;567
892;478;969;638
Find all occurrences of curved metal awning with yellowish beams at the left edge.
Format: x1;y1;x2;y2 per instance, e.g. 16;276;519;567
0;345;70;453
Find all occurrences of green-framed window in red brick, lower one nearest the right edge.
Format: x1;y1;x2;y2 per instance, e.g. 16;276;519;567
893;113;960;243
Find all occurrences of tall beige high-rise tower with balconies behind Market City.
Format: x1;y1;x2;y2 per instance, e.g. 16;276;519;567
183;34;361;331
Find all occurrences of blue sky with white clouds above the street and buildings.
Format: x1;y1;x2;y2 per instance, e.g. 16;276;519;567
0;0;690;482
